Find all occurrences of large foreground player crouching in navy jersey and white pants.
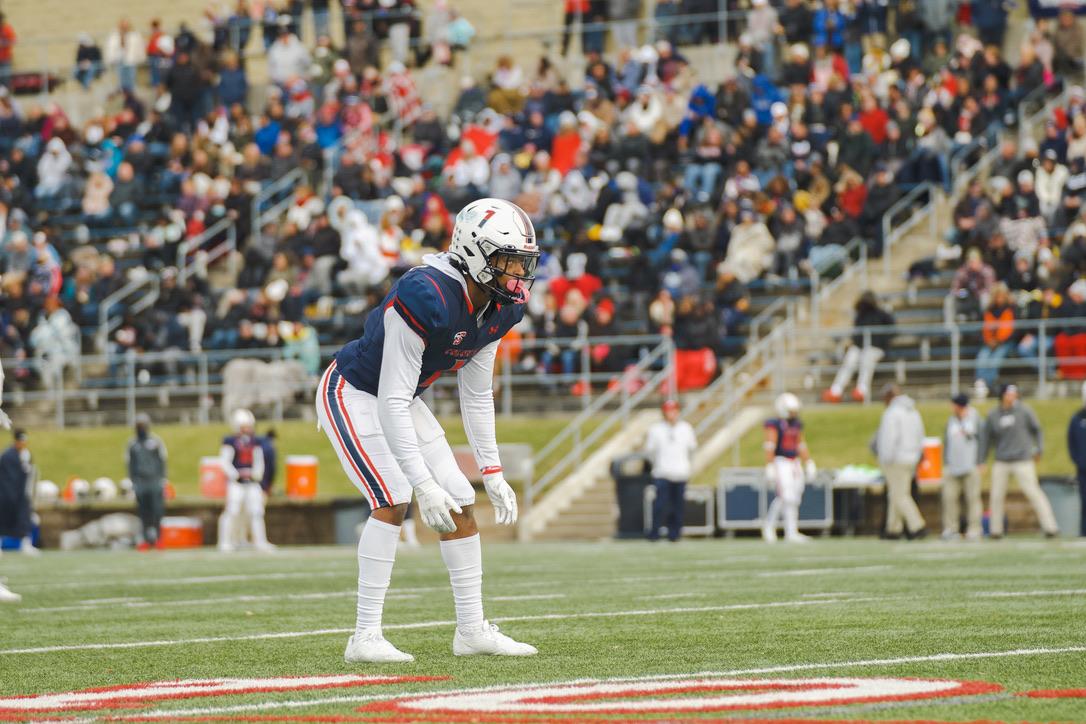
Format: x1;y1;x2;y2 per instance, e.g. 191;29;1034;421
316;199;540;663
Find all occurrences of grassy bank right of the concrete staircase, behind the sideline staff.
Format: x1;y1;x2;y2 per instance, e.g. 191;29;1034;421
694;399;1082;485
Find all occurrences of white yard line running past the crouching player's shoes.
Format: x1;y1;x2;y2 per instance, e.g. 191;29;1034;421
0;598;873;656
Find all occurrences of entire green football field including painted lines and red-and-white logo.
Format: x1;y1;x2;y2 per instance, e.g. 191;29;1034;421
0;537;1086;722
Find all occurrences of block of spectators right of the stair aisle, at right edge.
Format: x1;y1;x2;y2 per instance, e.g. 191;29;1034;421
933;70;1086;397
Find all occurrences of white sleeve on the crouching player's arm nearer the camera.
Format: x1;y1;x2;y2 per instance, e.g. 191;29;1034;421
377;307;433;487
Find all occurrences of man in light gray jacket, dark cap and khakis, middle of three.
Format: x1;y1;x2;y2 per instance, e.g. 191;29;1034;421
943;395;984;541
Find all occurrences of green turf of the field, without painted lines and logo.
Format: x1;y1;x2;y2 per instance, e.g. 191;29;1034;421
0;538;1086;721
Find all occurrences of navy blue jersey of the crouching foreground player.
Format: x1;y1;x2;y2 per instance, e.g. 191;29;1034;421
336;265;525;397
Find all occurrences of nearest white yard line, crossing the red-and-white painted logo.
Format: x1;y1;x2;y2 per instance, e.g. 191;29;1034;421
127;646;1086;720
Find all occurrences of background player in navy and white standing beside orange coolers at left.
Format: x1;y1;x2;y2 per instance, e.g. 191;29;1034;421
218;409;275;552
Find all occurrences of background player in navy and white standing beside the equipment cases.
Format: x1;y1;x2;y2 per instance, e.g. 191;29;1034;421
761;392;818;543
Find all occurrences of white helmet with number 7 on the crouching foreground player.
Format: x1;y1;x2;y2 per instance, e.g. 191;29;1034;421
449;199;540;304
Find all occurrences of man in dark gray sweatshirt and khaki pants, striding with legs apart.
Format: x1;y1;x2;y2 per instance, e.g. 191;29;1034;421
981;384;1059;538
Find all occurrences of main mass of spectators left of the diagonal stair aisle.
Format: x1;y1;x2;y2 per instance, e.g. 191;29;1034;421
0;0;1086;397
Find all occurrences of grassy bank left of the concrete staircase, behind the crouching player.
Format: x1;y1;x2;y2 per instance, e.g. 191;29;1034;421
21;416;596;497
